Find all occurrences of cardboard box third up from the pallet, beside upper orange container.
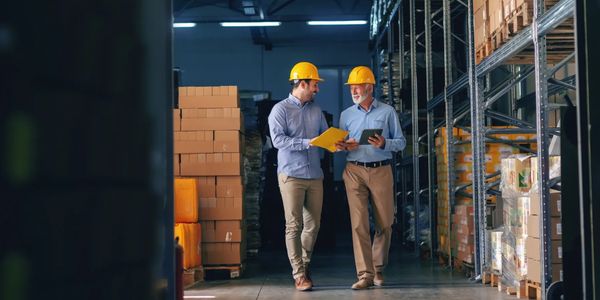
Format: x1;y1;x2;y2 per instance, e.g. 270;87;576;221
198;197;244;221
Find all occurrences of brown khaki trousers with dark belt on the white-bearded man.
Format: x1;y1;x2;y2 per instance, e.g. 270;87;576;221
343;163;394;279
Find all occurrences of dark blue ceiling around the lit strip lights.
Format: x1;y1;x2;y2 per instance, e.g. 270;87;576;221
173;0;372;49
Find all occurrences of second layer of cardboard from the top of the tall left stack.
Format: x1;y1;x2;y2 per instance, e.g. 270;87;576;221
181;108;244;131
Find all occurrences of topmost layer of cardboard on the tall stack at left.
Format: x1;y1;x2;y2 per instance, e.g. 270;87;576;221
179;86;240;108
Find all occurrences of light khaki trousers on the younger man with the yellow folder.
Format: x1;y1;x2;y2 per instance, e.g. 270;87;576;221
278;173;323;279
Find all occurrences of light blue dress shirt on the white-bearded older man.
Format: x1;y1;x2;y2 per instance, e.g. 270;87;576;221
340;99;406;162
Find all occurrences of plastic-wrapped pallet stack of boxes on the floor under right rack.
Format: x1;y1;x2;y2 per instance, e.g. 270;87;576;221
501;154;562;290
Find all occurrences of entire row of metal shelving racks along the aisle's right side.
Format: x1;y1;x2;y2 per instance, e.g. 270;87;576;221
372;0;575;294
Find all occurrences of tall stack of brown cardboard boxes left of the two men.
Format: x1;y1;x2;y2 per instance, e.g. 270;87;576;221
174;86;246;269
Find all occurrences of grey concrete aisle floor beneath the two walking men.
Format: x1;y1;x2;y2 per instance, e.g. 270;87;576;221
185;243;515;300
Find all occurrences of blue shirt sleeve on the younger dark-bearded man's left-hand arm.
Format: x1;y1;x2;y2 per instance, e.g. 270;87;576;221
269;105;310;151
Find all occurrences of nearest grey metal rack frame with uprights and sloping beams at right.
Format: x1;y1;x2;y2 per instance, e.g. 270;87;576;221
426;0;575;297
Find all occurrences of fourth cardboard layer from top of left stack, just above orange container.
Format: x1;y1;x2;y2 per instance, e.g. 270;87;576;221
181;153;242;176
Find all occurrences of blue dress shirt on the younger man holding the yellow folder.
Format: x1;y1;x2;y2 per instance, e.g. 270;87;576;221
269;94;328;179
